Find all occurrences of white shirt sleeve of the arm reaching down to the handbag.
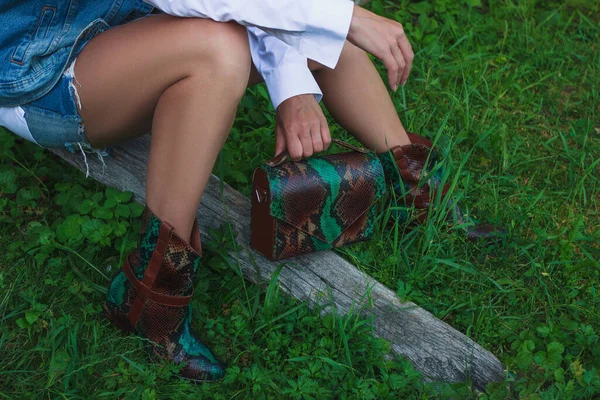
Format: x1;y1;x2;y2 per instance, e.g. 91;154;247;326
248;27;323;110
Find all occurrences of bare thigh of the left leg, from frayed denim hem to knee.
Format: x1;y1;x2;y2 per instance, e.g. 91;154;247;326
74;14;250;147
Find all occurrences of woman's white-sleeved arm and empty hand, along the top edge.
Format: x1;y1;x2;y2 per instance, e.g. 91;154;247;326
145;0;414;90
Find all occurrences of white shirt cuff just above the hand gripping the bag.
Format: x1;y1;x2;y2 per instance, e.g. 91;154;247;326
263;63;323;110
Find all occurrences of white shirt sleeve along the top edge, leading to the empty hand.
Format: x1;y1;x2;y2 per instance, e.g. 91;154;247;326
144;0;354;68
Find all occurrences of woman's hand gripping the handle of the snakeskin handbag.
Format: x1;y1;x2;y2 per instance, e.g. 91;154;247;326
275;94;331;161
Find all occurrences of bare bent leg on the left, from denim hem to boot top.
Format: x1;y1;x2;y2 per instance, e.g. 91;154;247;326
75;15;251;240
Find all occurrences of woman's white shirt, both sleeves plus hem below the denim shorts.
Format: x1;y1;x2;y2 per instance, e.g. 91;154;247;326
0;0;354;141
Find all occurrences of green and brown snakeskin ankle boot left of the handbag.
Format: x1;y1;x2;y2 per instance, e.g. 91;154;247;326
104;207;225;381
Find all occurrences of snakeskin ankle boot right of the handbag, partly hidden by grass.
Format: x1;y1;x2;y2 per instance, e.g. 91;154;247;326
378;133;506;244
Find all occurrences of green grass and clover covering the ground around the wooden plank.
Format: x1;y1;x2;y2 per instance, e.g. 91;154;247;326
0;0;600;399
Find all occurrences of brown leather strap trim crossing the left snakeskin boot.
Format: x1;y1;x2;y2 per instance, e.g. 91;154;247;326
123;222;191;327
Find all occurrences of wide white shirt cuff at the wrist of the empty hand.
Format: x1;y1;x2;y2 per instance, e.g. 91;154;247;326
298;0;354;69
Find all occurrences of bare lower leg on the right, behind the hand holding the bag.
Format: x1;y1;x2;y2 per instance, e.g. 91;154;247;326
309;42;410;152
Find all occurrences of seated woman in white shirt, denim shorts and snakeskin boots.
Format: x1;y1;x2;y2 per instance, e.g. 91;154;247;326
0;0;500;381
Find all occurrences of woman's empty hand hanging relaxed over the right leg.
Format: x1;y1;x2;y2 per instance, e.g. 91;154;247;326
348;6;414;91
